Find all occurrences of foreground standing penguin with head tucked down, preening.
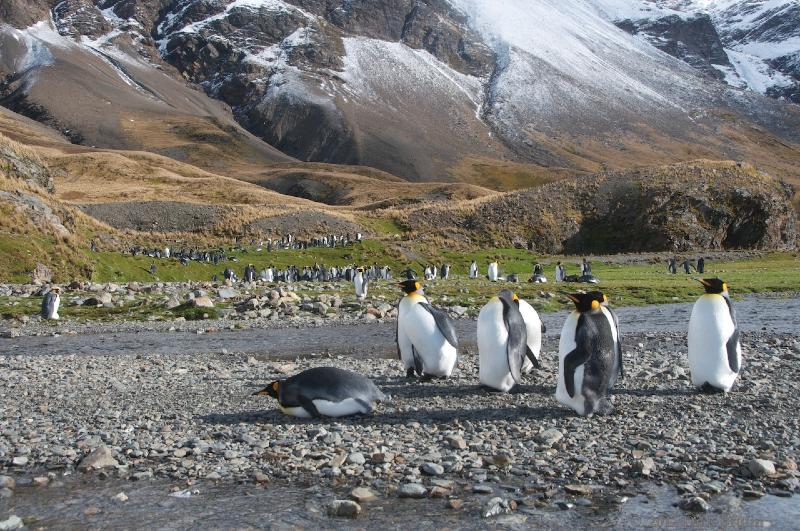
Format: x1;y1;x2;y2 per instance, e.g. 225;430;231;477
478;290;528;393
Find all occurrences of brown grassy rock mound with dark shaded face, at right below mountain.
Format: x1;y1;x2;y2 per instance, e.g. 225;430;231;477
409;162;797;254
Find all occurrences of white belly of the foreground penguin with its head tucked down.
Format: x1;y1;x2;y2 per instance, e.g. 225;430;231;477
478;300;516;393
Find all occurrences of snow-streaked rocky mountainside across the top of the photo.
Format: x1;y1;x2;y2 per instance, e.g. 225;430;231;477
0;0;800;180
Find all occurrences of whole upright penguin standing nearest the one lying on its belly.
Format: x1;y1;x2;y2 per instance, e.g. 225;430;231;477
397;280;458;378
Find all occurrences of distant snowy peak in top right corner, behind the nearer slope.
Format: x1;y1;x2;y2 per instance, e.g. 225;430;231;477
593;0;800;103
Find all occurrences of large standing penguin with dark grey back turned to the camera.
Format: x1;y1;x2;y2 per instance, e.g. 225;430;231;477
556;291;623;416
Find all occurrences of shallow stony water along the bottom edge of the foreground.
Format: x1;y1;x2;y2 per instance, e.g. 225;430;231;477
0;477;800;529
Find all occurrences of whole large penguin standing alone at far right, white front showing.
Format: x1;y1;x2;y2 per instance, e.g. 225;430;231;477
688;278;742;393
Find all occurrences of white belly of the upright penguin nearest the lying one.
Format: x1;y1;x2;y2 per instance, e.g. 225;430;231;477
398;296;458;377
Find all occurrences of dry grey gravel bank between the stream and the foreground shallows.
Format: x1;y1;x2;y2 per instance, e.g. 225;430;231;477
0;320;800;514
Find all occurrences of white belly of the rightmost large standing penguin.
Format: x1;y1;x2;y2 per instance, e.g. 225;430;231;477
688;295;741;392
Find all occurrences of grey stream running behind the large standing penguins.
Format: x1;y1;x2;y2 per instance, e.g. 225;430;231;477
0;298;800;358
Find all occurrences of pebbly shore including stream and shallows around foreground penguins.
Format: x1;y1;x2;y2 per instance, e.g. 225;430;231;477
0;298;800;528
